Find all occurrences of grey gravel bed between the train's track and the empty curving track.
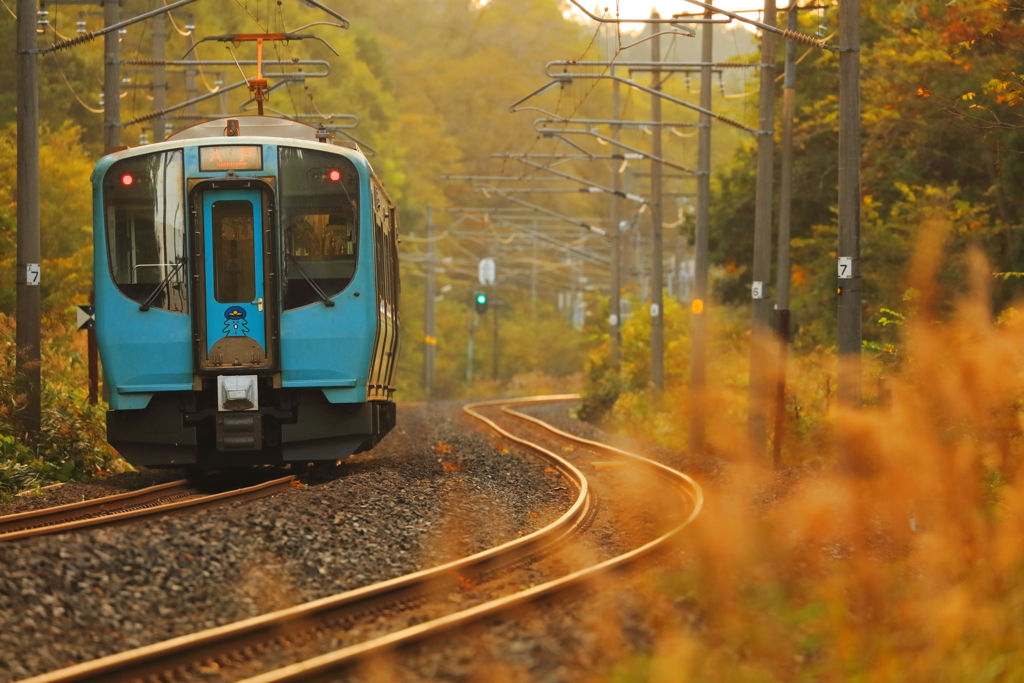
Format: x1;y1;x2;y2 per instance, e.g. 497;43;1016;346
0;404;571;683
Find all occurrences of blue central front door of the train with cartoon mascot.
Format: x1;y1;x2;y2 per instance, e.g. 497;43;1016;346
197;189;272;370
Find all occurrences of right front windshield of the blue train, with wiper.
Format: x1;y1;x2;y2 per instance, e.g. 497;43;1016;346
279;146;359;310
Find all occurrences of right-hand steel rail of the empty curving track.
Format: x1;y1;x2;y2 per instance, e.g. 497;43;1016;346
227;394;703;683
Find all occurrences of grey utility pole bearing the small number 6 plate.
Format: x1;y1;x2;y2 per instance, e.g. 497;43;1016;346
746;0;775;459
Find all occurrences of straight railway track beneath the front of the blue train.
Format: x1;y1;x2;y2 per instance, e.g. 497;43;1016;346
0;476;295;543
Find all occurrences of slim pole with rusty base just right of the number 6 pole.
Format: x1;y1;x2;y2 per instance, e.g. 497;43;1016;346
772;0;798;467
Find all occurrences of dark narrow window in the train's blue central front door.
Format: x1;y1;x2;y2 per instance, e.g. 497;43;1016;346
210;201;256;303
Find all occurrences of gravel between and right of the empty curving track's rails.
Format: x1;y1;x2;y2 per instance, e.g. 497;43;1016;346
186;403;700;683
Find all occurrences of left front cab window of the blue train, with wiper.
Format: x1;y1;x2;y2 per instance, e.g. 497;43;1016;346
103;150;188;313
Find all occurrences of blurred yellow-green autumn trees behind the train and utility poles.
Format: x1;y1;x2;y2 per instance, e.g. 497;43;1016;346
0;0;1024;475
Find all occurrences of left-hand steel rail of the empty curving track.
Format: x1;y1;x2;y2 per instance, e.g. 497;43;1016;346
22;396;596;683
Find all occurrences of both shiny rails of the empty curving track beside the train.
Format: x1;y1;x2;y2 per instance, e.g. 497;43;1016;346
25;394;702;683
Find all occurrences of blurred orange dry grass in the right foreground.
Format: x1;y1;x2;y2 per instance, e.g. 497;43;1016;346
612;223;1024;682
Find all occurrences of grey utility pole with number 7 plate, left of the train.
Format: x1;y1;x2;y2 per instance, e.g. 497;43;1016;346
15;0;42;436
